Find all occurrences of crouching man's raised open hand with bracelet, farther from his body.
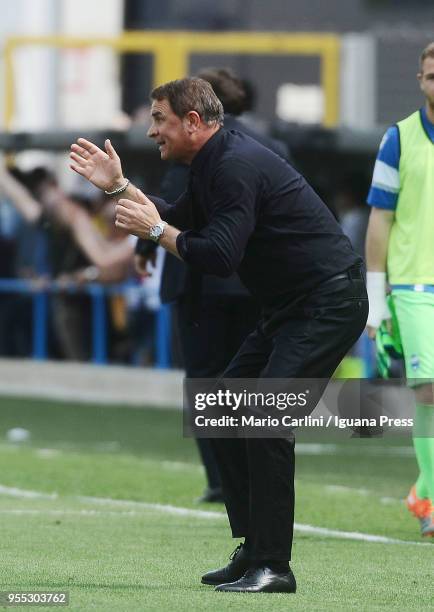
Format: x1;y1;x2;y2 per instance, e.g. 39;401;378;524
70;138;125;191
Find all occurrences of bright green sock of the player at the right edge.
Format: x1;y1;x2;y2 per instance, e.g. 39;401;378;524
413;403;434;502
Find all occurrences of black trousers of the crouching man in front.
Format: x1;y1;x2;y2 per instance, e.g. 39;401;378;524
213;271;368;561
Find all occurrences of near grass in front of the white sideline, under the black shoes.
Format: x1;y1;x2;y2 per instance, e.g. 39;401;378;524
0;500;432;612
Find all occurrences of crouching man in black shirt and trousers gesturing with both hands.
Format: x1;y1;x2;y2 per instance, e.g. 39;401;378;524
71;78;368;593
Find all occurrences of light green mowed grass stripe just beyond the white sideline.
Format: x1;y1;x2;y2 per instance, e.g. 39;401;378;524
0;447;424;541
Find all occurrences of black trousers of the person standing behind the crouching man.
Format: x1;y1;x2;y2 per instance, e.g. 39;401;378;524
176;294;260;488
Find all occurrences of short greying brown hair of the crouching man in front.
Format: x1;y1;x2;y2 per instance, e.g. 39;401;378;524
151;77;224;125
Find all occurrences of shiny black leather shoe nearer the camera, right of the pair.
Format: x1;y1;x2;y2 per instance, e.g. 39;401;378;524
216;566;297;593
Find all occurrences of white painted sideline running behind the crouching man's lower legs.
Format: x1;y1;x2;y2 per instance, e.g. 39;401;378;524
0;485;432;546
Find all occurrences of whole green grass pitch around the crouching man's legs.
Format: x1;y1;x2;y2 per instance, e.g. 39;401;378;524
0;398;434;612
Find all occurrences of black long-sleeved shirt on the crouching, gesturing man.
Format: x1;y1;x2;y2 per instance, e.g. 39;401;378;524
152;130;361;309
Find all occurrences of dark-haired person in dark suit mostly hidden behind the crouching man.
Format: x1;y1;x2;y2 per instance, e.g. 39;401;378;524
136;68;287;502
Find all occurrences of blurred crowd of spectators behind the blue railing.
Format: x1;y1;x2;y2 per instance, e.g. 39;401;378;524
0;160;161;364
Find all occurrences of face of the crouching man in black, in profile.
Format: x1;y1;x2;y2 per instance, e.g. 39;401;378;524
148;100;190;161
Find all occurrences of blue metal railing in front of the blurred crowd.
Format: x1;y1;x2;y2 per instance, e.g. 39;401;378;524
0;278;171;368
